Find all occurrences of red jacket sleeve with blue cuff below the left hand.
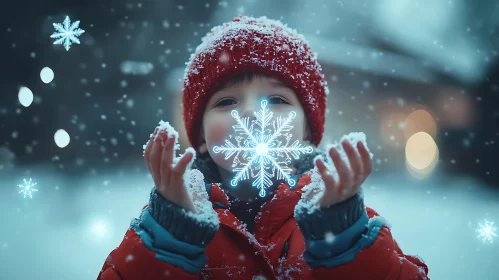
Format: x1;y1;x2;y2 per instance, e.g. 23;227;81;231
97;189;218;280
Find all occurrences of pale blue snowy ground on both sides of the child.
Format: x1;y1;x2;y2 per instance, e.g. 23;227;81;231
0;164;499;280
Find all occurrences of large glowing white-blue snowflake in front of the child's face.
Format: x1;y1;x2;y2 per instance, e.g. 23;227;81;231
213;100;313;197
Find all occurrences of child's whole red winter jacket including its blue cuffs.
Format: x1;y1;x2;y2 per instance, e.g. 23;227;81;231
98;171;429;280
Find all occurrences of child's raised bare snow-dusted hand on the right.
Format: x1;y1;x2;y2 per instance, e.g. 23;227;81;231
315;140;372;208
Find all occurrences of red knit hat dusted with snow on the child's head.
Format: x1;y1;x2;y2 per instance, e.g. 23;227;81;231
183;16;329;150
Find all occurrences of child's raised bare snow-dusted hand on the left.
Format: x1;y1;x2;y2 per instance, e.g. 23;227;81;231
144;128;195;212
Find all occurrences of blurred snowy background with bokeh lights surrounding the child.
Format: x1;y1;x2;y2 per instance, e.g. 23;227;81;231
0;0;499;280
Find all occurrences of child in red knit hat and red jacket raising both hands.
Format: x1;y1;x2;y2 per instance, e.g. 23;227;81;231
98;16;428;280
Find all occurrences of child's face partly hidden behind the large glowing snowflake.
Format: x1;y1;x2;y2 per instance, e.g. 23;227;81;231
200;77;308;171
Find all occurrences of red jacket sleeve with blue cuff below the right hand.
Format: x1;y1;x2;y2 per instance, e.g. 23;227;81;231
295;188;429;280
